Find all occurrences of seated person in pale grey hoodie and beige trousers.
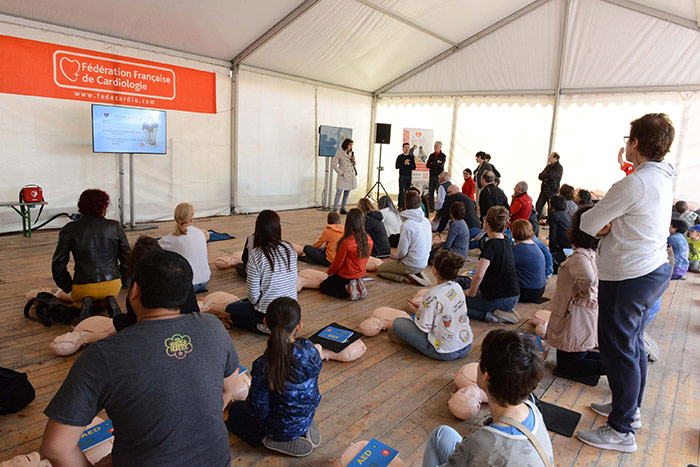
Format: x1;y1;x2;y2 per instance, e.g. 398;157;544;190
377;189;433;287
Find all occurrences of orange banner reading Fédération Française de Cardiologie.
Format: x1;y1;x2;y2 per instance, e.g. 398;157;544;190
0;35;216;113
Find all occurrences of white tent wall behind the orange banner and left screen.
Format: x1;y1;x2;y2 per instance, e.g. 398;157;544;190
0;23;231;232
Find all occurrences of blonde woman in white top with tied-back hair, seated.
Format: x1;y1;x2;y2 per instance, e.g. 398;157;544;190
158;203;211;292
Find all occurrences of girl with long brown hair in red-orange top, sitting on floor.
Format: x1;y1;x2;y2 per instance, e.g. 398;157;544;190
321;208;373;300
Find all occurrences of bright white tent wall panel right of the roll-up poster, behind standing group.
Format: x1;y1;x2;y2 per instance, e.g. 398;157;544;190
452;96;553;203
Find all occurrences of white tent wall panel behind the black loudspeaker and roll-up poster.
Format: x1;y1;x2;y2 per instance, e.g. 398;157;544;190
372;98;454;194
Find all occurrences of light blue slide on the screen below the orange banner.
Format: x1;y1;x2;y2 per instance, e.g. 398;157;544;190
92;104;166;154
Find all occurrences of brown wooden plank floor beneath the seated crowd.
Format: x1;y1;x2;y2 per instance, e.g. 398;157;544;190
0;209;700;466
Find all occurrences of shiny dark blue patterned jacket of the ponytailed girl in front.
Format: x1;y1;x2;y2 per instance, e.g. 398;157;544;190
246;338;322;441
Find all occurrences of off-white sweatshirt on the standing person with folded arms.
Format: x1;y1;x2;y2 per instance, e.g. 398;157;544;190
581;162;676;281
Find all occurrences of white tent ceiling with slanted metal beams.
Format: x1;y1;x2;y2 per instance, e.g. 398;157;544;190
0;0;700;95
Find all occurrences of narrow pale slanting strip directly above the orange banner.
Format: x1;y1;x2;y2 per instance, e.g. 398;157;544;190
0;14;231;69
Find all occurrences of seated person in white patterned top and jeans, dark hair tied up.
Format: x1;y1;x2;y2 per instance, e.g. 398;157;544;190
389;250;473;360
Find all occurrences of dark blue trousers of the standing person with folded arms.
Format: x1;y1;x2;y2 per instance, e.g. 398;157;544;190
598;263;671;433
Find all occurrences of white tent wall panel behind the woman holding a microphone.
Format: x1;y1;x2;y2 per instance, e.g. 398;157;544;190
235;69;371;213
